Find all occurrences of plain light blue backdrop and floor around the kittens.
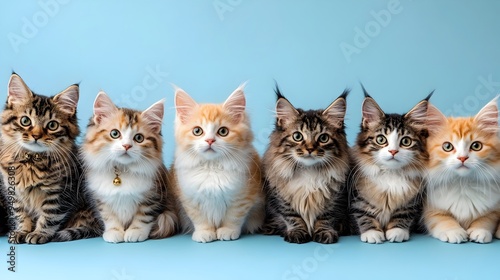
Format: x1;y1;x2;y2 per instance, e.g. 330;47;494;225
0;0;500;279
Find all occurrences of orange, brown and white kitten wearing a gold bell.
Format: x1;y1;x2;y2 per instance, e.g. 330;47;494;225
81;91;178;243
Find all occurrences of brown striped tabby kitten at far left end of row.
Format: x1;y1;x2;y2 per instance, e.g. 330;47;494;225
0;74;101;244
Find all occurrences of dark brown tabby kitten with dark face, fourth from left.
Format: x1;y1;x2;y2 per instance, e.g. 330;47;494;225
263;85;349;243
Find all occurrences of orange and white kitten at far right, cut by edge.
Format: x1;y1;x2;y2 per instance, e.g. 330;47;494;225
424;98;500;243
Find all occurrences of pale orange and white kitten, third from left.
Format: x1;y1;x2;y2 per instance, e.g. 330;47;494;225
172;86;264;242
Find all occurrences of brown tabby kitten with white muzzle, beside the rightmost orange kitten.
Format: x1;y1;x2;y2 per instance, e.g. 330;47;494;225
349;88;432;243
